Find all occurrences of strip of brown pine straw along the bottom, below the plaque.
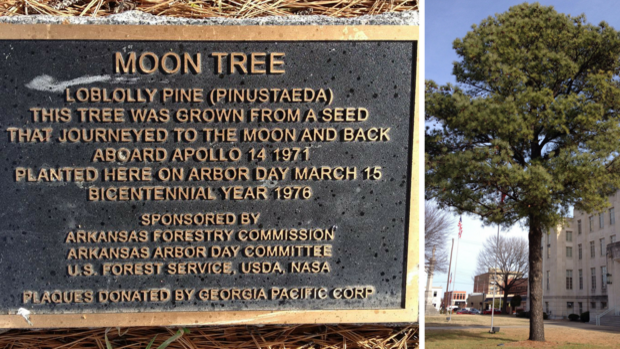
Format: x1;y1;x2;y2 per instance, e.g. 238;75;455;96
0;325;418;349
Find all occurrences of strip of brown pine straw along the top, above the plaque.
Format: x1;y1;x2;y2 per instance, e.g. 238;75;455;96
0;0;418;18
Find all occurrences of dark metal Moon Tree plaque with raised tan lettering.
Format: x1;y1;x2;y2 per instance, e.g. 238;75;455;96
0;26;418;327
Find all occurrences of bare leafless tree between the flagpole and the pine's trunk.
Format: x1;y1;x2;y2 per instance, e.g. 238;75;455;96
476;235;529;312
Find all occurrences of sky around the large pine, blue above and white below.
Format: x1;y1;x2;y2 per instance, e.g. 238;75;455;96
424;0;620;300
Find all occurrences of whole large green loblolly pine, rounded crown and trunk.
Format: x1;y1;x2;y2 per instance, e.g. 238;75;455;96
425;3;620;341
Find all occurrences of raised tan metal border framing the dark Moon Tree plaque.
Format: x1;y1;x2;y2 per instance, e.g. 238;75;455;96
0;24;423;328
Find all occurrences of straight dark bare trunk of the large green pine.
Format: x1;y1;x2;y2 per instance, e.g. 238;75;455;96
528;214;545;342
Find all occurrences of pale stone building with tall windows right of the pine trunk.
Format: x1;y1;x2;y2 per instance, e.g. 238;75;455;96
541;193;620;318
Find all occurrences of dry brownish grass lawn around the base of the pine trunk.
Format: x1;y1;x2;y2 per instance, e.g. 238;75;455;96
425;327;620;349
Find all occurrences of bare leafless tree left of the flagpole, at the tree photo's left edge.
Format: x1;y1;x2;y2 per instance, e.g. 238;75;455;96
424;202;456;273
